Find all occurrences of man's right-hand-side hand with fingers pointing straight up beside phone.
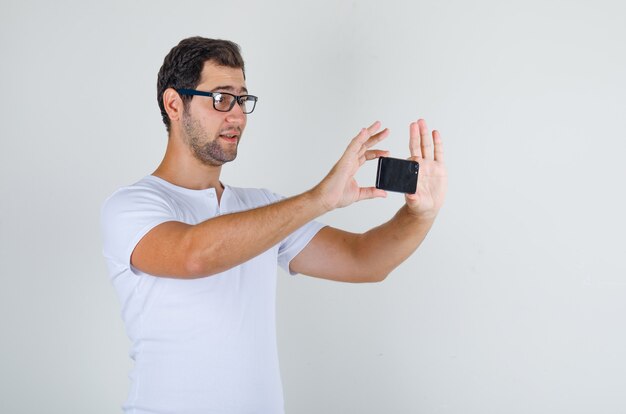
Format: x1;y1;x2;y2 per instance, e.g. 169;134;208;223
406;119;448;218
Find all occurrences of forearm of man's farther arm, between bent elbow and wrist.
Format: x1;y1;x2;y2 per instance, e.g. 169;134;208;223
353;205;436;280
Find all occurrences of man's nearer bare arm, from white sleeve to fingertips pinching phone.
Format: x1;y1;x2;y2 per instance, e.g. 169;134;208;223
131;122;388;278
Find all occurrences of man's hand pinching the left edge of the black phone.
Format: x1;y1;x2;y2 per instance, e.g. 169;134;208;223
314;121;389;211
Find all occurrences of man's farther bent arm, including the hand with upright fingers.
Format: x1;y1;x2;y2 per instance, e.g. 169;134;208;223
290;120;447;282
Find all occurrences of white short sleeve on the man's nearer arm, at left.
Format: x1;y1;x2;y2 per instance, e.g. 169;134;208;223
101;187;176;269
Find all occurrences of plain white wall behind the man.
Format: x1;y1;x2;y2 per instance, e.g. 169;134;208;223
0;0;626;414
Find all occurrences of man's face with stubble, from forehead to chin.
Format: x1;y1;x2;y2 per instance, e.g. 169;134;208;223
182;61;248;167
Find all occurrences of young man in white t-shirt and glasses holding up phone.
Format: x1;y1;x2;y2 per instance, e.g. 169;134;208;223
102;37;447;414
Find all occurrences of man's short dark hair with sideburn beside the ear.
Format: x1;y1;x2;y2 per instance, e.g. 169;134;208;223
157;36;245;132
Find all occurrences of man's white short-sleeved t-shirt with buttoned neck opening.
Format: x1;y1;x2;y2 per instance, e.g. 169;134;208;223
102;176;323;414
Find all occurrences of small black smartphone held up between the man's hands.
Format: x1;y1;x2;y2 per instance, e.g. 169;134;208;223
376;157;420;194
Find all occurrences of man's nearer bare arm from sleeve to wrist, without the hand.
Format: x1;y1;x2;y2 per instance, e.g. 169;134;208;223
136;190;326;279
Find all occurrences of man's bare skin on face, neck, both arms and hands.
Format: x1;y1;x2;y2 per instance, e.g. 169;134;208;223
131;62;447;282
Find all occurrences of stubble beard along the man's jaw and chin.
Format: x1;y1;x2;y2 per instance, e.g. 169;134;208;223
183;113;239;167
